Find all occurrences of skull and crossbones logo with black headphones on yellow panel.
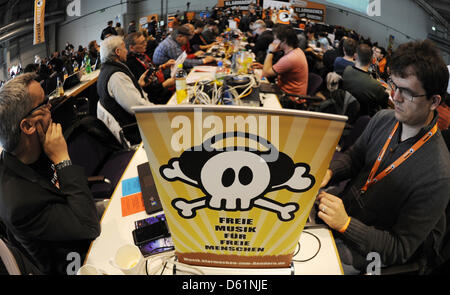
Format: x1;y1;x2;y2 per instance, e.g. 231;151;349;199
160;133;315;221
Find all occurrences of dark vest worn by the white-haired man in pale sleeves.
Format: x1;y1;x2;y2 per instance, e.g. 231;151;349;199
97;61;145;144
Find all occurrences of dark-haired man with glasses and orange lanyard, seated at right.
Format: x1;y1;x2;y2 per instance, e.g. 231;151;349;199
318;40;450;273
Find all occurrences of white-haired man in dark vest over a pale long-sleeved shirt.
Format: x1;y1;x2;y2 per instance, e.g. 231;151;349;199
97;36;153;144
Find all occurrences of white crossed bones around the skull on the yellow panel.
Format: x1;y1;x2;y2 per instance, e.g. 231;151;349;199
161;160;313;221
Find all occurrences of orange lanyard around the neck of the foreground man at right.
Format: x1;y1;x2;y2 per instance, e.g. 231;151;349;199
361;122;438;193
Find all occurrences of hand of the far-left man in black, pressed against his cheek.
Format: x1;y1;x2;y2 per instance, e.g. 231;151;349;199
36;121;70;164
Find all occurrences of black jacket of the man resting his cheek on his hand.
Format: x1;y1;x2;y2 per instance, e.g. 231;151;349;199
0;151;100;274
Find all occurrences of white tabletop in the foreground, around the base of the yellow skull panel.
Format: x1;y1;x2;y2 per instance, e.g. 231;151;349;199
85;145;343;275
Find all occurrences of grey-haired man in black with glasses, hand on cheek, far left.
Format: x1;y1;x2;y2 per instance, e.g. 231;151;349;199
0;73;100;274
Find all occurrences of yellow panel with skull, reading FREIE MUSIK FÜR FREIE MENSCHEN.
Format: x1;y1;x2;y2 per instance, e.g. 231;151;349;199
133;105;347;269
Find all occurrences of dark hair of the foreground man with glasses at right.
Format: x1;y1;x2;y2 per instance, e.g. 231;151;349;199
389;40;449;98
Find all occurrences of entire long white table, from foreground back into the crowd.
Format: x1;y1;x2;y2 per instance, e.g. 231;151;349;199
84;61;343;275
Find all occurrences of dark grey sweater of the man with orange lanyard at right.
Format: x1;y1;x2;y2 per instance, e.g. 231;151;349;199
330;110;450;276
